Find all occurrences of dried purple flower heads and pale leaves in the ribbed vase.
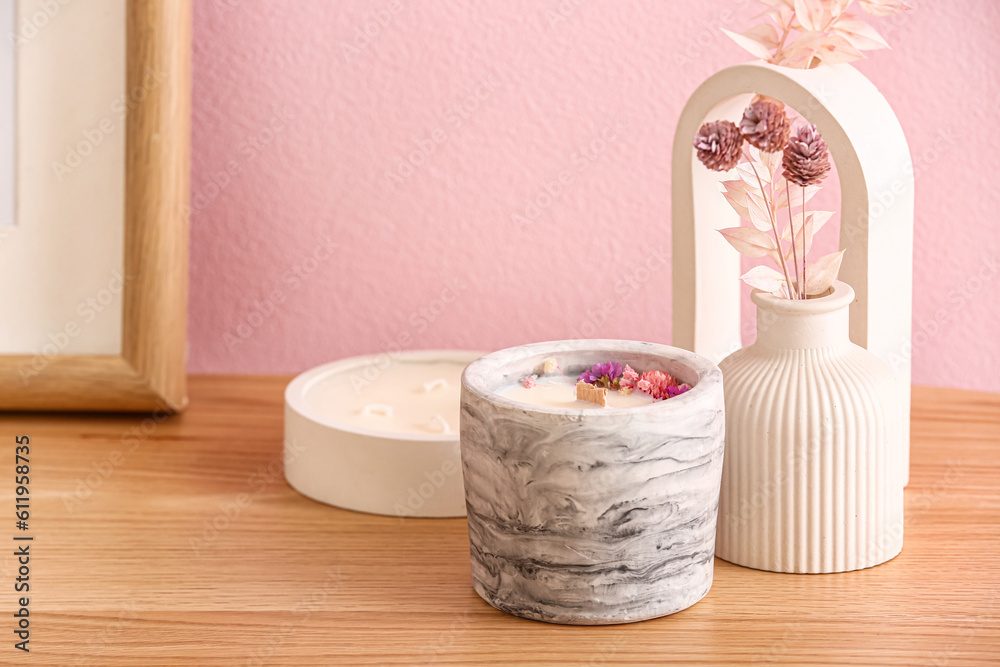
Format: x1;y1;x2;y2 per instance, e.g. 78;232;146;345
694;98;844;299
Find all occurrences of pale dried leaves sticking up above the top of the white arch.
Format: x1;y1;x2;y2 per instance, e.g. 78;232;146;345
723;0;911;69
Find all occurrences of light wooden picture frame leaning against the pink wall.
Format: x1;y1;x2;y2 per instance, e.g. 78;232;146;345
0;0;191;412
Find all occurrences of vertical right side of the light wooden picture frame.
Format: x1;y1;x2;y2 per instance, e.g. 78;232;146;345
122;0;191;409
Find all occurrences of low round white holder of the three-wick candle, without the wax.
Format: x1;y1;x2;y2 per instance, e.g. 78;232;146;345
284;350;481;517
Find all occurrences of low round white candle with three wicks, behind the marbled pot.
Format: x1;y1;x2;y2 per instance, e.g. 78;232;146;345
284;350;481;517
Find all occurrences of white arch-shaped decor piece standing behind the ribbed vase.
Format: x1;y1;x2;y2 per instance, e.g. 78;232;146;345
672;61;913;482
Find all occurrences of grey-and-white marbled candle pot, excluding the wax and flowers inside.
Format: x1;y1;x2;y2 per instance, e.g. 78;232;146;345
461;340;725;625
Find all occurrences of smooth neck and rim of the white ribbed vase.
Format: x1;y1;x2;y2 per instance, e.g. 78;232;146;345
751;282;854;350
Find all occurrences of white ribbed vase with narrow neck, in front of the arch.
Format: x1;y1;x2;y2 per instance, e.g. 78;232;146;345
716;281;909;573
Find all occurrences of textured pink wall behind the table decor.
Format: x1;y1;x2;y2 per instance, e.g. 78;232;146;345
190;0;1000;391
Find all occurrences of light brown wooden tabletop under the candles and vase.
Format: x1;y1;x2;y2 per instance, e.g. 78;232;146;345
0;376;1000;665
